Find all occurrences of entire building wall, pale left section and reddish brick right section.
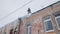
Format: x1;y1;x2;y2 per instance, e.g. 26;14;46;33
0;1;60;34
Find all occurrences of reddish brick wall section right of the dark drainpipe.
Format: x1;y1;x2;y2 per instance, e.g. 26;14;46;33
20;1;60;34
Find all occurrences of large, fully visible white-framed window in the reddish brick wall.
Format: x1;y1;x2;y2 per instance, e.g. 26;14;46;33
44;17;53;32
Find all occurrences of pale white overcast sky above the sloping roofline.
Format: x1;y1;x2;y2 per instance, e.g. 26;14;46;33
0;0;59;27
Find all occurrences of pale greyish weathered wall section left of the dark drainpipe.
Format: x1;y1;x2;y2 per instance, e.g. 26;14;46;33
0;20;19;34
